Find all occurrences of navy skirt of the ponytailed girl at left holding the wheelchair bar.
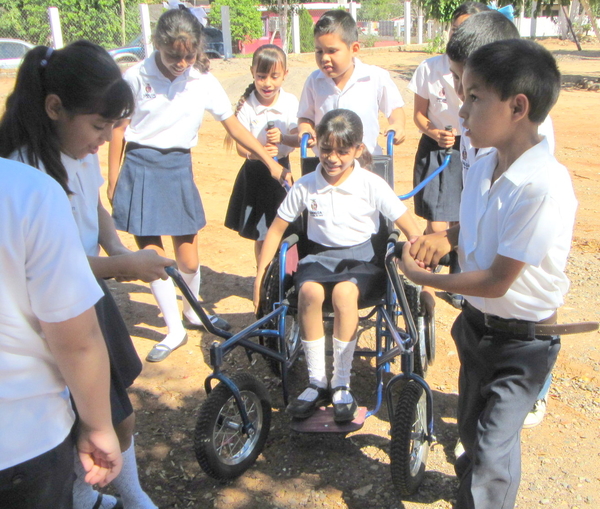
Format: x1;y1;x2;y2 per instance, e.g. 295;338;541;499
96;279;142;425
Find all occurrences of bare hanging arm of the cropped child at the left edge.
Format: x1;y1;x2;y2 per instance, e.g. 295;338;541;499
40;307;122;486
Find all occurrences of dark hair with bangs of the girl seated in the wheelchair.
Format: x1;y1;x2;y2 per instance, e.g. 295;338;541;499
316;108;373;168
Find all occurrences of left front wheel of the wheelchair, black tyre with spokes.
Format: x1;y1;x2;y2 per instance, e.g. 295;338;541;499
194;373;271;480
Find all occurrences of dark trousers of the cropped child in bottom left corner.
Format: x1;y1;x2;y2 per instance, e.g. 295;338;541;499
0;435;75;509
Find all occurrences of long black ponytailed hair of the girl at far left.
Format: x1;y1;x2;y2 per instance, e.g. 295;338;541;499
0;41;135;193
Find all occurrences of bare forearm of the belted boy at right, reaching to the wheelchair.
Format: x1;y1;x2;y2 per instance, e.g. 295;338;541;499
399;243;525;299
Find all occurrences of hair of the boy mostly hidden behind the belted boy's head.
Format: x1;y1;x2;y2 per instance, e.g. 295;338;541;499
446;10;519;63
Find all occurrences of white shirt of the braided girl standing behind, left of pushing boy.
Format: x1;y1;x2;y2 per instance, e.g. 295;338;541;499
238;88;298;159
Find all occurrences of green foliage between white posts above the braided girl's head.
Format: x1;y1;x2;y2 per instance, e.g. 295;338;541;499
208;0;263;42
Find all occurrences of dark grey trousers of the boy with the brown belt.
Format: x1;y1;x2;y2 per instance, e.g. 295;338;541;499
452;306;560;509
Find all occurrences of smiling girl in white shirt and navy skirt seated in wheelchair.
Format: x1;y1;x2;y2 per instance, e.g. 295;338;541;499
254;109;421;423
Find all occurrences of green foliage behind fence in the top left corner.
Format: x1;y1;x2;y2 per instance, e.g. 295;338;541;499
0;0;140;48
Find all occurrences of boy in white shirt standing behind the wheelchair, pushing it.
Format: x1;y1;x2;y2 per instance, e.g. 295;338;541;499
298;10;405;155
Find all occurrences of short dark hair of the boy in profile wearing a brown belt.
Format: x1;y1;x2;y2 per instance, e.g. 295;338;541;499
466;39;560;124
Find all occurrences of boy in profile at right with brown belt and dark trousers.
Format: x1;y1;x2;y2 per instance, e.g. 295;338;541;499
401;39;580;509
